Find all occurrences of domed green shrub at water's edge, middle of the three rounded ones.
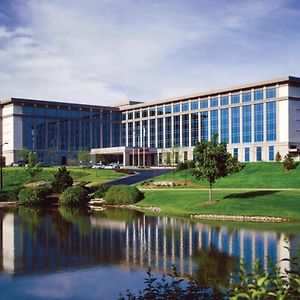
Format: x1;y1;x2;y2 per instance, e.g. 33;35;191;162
59;186;90;206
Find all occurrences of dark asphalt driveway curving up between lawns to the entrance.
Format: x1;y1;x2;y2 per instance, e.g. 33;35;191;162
104;169;170;185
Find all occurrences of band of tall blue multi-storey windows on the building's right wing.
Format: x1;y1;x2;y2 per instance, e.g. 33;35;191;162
122;101;276;148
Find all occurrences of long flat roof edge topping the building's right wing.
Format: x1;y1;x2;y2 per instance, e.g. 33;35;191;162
120;76;300;111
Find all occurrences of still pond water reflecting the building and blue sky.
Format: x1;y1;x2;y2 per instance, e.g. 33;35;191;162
0;208;300;299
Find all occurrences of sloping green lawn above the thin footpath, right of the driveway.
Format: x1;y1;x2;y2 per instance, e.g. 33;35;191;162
146;162;300;188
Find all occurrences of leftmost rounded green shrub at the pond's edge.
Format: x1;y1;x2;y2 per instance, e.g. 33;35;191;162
18;187;50;206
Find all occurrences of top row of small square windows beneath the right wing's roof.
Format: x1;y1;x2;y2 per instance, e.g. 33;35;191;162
122;87;276;120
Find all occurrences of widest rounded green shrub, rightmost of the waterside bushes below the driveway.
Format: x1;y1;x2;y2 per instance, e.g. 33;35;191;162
104;185;144;205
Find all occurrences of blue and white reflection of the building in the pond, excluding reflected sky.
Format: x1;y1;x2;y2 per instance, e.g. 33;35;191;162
1;208;300;282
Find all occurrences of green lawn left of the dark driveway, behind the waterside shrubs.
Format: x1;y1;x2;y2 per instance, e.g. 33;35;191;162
3;167;124;189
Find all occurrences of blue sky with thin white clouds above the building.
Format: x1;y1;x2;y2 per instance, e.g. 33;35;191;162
0;0;300;105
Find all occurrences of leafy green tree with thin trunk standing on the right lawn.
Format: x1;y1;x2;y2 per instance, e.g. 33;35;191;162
193;135;242;201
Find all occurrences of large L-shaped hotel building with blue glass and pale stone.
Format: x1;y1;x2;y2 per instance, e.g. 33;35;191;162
1;76;300;166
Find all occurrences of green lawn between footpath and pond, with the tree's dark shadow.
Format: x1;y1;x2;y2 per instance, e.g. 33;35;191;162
138;188;300;220
